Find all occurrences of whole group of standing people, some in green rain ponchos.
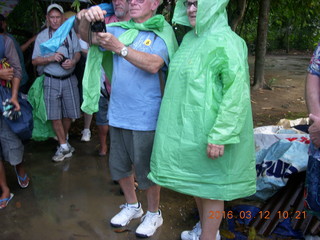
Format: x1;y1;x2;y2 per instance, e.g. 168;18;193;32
0;0;320;240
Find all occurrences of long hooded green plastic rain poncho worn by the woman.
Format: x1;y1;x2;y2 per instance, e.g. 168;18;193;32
148;0;256;200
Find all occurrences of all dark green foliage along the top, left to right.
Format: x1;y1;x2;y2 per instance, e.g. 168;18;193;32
3;0;320;50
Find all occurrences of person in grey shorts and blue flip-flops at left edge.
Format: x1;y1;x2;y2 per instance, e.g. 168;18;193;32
0;27;30;209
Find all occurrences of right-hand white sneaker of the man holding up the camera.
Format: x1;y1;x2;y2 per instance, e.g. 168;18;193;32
136;210;163;237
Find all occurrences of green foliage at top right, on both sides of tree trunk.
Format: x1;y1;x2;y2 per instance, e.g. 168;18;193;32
232;0;320;51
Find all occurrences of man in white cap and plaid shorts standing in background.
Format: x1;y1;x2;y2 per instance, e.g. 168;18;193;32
32;4;80;162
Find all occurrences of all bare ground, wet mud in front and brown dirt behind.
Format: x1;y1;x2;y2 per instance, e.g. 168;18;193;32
0;54;310;240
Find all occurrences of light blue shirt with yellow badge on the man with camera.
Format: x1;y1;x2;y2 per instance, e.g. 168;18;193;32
108;27;169;131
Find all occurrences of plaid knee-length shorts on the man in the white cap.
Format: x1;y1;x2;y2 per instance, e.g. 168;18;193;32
43;75;80;120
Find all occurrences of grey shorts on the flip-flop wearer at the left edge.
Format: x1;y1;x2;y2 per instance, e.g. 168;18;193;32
0;116;24;166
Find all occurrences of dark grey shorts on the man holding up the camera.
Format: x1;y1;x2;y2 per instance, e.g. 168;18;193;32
109;127;155;190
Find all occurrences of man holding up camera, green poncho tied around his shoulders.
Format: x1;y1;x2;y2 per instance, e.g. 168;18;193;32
77;0;177;237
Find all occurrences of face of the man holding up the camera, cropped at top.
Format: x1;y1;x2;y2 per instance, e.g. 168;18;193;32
127;0;159;23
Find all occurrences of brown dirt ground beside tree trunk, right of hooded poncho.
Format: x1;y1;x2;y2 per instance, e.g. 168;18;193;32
249;54;311;127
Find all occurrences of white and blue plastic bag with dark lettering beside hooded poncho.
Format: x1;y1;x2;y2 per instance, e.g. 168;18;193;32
254;126;310;200
